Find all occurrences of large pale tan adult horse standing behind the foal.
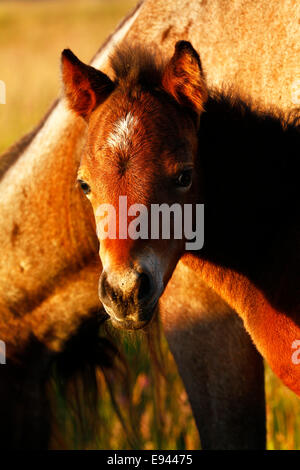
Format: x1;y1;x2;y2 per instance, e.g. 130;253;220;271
1;1;296;448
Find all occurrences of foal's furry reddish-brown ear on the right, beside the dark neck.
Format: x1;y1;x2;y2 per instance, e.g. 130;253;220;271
162;41;208;116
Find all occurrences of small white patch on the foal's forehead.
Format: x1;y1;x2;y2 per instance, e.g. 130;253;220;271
107;113;138;150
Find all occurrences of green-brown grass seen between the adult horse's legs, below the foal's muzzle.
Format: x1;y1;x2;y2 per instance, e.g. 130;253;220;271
51;333;200;450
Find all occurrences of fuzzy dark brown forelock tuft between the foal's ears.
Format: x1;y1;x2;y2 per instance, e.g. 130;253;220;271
110;44;164;88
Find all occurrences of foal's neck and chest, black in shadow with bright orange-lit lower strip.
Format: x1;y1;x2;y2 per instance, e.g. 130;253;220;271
183;95;300;395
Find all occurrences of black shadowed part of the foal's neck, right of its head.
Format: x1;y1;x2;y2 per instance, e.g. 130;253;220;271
196;89;300;308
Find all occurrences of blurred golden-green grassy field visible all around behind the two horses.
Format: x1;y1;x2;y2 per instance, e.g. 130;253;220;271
0;0;300;449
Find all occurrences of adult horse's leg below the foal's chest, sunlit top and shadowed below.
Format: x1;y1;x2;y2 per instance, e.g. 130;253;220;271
160;263;266;449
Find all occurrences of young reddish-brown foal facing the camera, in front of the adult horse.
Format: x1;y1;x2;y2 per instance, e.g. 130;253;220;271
62;41;300;394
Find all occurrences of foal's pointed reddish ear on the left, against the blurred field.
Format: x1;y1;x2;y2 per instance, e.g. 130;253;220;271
61;49;114;119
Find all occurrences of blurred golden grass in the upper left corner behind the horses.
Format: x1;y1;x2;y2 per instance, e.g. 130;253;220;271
0;0;136;153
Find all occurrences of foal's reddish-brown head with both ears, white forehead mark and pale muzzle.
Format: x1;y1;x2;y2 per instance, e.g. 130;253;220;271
62;41;207;328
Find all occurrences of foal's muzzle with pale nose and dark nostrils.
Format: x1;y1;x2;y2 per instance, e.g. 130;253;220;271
99;269;161;330
